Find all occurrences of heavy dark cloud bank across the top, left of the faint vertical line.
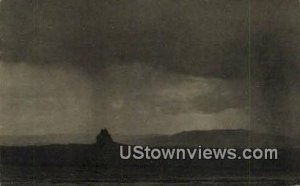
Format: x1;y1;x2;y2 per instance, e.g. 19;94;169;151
1;0;247;77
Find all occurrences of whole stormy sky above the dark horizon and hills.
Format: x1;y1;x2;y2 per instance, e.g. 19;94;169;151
0;0;300;136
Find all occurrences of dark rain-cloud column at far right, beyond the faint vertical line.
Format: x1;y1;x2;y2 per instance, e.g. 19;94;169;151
251;0;300;135
